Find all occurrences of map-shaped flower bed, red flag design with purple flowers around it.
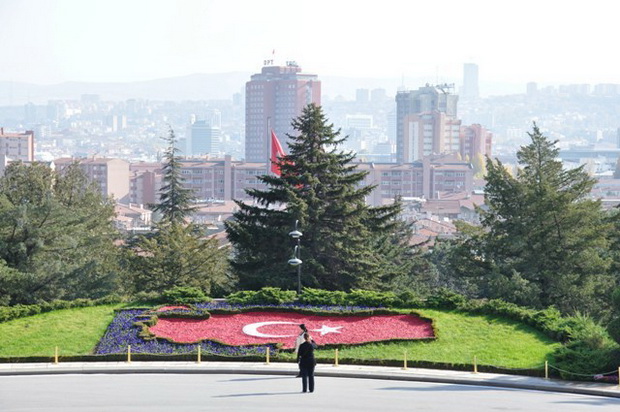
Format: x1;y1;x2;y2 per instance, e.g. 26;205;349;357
96;305;435;356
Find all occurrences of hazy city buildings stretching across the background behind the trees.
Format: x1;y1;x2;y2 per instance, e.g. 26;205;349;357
0;61;620;245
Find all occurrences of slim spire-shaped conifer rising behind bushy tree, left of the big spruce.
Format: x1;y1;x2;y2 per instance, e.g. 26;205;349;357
153;129;195;224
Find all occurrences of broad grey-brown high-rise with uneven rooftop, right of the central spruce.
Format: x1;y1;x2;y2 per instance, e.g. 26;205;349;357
396;84;461;163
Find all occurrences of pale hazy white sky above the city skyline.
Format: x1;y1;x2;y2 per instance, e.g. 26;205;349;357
0;0;620;89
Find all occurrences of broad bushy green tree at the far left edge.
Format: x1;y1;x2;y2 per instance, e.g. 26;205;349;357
0;162;118;303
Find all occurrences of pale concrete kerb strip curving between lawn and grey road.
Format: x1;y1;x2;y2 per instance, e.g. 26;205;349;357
0;361;620;398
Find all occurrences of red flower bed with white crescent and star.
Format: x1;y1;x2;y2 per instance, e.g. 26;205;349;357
149;312;434;348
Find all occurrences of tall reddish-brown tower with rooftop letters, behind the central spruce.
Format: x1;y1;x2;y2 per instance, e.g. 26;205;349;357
245;61;321;162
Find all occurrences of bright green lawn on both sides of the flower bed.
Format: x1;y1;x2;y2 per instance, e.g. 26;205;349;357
0;305;560;369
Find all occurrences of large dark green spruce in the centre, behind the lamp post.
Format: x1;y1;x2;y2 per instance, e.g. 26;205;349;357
226;104;406;290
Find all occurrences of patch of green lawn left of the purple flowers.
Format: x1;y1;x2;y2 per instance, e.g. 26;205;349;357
0;305;123;357
